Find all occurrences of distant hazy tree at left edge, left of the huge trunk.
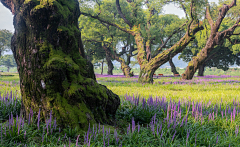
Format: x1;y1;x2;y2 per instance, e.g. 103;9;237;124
0;30;13;57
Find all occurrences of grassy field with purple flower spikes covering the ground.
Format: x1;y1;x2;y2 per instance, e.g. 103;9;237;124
0;75;240;147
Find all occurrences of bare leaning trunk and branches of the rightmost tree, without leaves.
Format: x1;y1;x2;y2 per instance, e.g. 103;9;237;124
182;0;240;80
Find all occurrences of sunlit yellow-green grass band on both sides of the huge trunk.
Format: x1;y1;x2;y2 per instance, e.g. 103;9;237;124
0;73;240;103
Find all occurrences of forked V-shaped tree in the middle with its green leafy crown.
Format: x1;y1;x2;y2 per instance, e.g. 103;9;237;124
80;0;204;83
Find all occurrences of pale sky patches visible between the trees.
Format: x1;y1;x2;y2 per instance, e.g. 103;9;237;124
0;0;218;53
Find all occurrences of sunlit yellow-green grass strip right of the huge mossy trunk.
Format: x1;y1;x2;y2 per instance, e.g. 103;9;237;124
98;77;240;103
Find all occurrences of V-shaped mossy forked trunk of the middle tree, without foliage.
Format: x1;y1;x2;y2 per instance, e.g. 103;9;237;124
133;22;203;83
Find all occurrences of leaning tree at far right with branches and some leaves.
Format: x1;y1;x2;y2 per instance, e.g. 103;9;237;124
182;0;240;80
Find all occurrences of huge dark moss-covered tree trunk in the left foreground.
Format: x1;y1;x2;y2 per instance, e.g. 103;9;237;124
1;0;120;130
